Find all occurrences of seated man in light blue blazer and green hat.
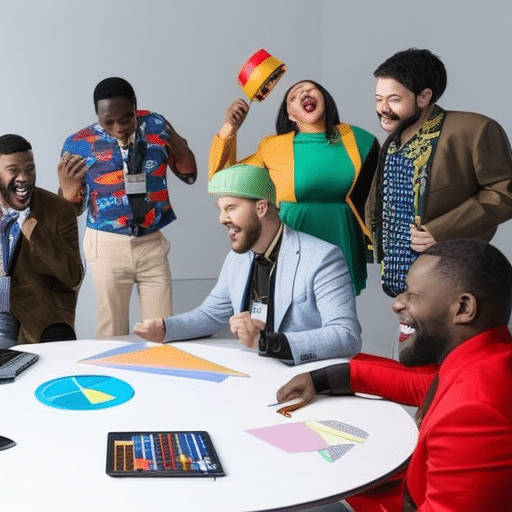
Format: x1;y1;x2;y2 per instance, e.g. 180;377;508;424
135;164;361;364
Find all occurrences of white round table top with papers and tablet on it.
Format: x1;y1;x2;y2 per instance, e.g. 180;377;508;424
0;340;417;512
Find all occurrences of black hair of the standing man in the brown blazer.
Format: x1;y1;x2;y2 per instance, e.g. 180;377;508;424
373;48;447;103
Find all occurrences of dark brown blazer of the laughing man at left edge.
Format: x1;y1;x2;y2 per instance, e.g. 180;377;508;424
9;188;83;343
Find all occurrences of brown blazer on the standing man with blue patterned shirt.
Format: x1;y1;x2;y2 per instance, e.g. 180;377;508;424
366;111;512;252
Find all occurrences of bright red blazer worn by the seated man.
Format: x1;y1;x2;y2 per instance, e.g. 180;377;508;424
350;326;512;512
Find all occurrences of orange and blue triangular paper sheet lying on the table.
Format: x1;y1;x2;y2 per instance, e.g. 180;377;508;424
79;343;247;382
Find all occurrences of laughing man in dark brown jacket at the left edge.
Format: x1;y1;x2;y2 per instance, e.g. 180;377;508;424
0;135;83;346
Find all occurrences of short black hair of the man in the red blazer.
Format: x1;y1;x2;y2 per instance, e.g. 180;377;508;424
420;238;512;323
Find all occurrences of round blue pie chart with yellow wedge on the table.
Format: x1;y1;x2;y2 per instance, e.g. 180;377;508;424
35;375;135;411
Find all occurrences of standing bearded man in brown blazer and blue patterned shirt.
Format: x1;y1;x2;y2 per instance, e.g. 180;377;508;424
366;48;512;296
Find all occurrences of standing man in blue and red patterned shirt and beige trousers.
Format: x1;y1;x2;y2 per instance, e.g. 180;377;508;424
58;77;197;338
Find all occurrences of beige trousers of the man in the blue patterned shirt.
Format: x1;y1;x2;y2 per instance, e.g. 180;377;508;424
84;228;172;338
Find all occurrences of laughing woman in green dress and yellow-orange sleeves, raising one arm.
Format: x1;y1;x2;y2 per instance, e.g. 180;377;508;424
209;80;379;295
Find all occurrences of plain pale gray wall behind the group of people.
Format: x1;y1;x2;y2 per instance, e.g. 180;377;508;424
0;0;512;345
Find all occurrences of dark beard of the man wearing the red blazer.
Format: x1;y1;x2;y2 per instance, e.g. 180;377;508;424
398;313;450;366
